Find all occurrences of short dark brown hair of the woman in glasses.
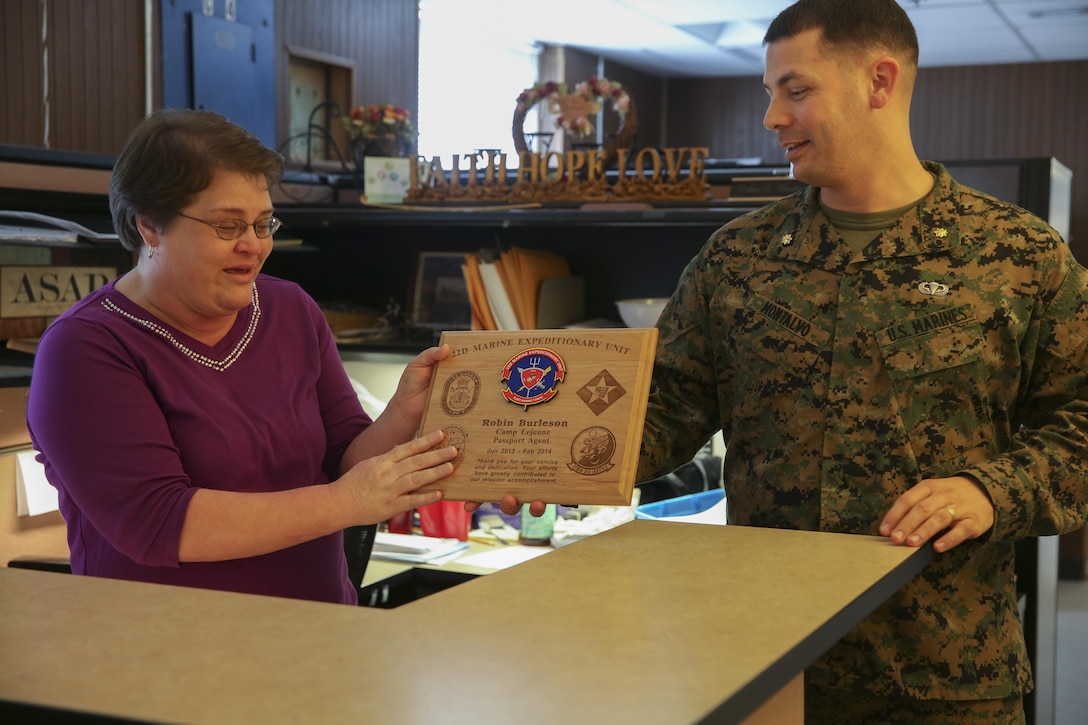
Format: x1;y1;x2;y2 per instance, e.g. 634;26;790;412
110;110;284;250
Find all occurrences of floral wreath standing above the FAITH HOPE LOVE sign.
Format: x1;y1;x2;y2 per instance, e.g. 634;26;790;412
514;76;639;168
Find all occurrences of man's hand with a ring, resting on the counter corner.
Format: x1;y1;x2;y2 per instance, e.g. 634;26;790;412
880;476;993;552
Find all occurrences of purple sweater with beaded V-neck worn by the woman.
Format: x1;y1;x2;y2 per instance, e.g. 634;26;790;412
27;275;370;604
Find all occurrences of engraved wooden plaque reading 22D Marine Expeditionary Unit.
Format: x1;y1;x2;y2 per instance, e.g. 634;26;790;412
420;328;657;506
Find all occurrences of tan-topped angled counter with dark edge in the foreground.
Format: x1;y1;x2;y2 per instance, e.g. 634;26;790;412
0;520;931;725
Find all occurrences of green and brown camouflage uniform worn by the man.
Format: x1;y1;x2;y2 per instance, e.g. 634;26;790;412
639;163;1088;700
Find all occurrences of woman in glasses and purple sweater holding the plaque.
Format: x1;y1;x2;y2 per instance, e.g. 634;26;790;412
27;111;456;604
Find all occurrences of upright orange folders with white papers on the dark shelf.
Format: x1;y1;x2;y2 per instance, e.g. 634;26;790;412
461;247;570;330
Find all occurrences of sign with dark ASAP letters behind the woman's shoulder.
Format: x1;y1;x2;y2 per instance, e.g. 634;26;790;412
0;266;118;318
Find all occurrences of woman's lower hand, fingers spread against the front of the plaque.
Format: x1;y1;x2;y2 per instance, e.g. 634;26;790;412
339;430;457;525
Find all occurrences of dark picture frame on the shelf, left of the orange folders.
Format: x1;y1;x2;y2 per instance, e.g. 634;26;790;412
411;251;472;331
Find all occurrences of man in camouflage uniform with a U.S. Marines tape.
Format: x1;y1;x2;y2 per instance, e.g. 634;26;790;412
638;0;1088;724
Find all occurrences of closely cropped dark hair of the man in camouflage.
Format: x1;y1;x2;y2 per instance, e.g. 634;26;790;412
763;0;918;67
